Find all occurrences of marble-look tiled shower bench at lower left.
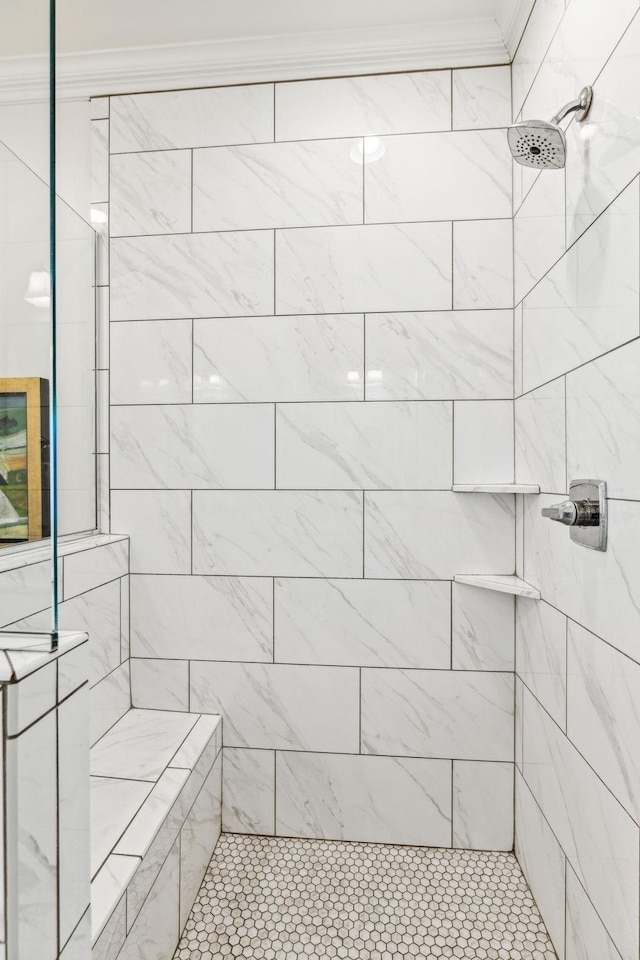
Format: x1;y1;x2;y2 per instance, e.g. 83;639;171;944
91;709;222;960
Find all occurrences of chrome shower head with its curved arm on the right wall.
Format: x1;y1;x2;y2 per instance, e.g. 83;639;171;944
507;87;593;170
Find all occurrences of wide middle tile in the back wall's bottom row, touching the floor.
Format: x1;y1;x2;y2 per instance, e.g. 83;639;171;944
276;753;451;847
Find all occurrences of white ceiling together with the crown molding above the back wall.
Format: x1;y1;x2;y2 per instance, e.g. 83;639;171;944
0;0;534;102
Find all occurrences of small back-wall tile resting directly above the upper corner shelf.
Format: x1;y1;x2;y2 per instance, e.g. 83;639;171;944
453;400;514;483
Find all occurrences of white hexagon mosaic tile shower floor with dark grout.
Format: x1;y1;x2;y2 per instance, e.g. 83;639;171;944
175;834;556;960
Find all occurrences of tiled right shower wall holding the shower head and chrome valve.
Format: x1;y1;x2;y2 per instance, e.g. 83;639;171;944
513;0;640;960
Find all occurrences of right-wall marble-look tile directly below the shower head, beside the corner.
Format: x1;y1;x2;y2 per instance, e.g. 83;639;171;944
513;161;565;303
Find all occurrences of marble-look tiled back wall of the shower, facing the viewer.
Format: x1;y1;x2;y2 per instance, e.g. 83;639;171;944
100;67;515;849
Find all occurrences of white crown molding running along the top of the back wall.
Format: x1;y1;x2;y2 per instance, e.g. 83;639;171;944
0;18;510;103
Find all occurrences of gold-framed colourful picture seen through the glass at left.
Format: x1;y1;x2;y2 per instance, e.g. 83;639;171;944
0;377;50;544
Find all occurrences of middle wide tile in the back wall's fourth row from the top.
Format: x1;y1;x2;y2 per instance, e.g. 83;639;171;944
193;315;364;403
